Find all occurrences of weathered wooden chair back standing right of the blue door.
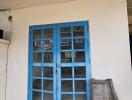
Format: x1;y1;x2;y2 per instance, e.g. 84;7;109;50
91;79;118;100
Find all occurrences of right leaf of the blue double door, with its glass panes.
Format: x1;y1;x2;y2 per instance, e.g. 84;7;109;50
57;23;90;100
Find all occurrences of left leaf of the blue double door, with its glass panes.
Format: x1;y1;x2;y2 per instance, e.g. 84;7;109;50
29;26;56;100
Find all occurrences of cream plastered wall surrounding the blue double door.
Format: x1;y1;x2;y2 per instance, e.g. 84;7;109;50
0;0;132;100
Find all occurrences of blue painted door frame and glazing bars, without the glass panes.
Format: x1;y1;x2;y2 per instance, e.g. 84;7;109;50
28;21;91;100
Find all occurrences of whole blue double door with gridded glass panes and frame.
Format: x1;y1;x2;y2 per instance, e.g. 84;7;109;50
28;21;91;100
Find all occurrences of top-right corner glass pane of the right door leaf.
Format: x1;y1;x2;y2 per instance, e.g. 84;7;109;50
73;26;84;37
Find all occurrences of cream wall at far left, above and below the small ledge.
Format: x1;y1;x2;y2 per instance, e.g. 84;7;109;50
0;11;11;100
